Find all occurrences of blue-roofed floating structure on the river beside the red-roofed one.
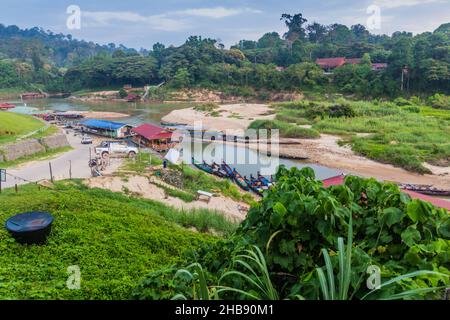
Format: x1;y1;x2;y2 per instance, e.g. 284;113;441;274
81;119;133;139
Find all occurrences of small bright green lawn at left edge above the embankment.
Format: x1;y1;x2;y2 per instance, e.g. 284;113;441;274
0;111;53;145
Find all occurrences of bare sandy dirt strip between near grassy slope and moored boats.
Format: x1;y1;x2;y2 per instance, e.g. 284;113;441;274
86;176;248;222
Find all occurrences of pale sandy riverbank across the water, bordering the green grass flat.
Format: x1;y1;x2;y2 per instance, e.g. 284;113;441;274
163;104;450;189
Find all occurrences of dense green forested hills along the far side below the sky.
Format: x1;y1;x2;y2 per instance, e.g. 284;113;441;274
0;14;450;97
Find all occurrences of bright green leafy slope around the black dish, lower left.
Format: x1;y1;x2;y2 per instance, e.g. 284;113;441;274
0;183;215;299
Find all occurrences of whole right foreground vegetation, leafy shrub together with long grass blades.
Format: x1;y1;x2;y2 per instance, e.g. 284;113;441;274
134;167;450;300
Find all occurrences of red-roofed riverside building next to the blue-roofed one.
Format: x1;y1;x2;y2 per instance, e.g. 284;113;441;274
131;123;176;152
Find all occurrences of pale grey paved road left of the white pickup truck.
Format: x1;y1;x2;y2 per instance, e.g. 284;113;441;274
2;133;118;188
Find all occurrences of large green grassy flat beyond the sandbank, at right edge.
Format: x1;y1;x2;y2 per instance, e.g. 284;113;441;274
275;101;450;173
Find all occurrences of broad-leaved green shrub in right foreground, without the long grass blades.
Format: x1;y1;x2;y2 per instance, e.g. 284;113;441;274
134;167;450;299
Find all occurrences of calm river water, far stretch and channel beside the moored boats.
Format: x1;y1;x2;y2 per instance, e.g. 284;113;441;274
12;99;342;179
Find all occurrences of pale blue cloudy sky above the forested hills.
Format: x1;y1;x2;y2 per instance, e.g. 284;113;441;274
0;0;450;49
